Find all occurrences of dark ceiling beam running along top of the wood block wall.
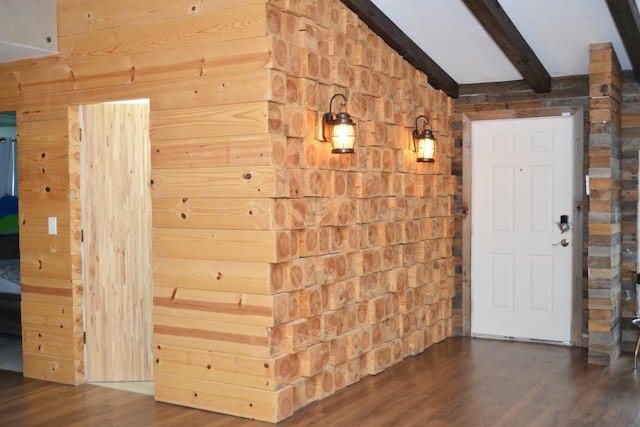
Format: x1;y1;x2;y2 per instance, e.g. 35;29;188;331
342;0;458;98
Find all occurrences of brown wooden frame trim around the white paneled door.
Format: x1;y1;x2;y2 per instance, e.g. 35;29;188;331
461;106;584;346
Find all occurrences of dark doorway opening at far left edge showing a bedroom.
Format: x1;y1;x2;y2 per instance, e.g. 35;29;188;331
0;111;23;372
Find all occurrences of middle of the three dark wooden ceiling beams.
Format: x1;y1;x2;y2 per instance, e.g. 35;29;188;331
462;0;553;93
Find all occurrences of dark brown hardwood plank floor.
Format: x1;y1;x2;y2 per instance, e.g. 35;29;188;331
0;338;640;427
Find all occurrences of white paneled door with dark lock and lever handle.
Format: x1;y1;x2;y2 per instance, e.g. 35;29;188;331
471;117;573;342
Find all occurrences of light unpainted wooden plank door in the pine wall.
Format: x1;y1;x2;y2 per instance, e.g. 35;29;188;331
81;103;153;382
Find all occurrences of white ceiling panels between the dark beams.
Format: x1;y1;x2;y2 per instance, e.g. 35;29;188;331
372;0;640;84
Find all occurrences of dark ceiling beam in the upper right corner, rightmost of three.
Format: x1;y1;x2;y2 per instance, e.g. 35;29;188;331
607;0;640;82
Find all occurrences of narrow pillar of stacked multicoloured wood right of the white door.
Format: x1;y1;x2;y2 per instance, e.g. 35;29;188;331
587;43;622;365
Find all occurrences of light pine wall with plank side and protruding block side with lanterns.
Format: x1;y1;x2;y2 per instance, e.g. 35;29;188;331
0;0;455;422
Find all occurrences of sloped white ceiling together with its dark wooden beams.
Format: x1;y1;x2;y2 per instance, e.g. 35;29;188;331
350;0;640;97
